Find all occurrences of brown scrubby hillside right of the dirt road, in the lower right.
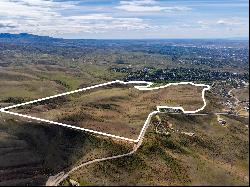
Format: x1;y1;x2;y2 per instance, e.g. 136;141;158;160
64;114;249;185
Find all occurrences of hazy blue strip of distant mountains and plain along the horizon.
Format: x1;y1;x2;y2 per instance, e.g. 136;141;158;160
0;33;248;51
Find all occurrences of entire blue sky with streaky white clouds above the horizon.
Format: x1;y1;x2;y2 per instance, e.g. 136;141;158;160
0;0;249;39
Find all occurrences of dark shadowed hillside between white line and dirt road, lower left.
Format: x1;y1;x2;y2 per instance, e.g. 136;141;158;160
0;114;131;185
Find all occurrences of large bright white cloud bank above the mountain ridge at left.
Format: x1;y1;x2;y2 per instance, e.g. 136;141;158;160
0;0;150;35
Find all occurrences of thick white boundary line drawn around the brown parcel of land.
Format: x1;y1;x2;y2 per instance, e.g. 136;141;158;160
0;80;211;143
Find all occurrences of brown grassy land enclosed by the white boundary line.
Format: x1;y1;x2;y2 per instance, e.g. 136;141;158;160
9;83;204;139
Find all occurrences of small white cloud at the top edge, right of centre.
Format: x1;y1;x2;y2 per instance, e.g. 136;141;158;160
115;0;191;12
